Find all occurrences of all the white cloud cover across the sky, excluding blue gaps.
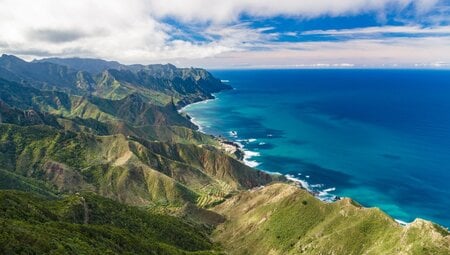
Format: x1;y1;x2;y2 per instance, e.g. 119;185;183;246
0;0;450;67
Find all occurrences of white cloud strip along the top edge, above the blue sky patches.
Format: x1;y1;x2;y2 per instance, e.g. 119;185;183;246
150;0;440;23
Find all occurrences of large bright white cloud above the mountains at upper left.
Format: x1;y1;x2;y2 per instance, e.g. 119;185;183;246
0;0;261;63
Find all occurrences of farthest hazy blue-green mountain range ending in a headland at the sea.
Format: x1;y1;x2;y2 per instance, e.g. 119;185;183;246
0;54;231;107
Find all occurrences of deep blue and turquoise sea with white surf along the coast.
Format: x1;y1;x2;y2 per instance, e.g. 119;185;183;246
184;70;450;227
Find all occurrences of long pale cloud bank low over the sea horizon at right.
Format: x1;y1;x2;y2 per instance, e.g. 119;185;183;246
180;36;450;68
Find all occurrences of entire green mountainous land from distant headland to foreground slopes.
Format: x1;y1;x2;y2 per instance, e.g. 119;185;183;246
0;55;450;254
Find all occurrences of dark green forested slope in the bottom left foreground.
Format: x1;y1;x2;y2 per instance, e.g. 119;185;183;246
0;191;221;254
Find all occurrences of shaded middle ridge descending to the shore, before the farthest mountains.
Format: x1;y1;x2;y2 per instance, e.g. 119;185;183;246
0;76;217;145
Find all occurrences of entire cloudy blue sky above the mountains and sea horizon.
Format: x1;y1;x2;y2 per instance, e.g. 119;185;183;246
0;0;450;69
